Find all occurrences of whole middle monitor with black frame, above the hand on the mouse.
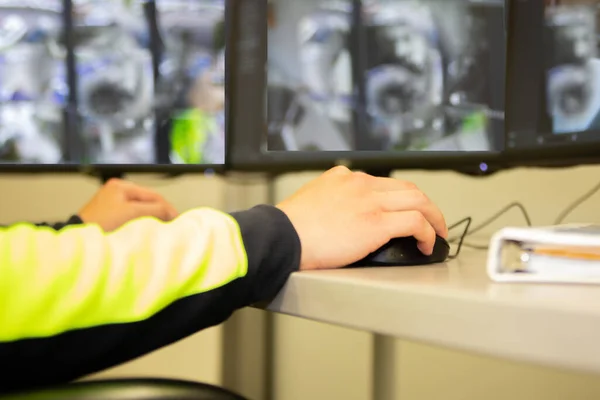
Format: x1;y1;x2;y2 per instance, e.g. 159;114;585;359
229;0;506;171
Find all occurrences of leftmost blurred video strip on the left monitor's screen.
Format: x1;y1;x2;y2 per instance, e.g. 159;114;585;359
0;0;68;164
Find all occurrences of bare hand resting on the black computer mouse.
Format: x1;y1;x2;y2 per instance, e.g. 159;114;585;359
277;167;448;270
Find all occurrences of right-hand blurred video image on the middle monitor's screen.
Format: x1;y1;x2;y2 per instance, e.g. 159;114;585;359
362;0;505;151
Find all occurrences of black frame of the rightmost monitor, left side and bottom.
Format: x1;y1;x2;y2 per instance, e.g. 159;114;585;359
503;0;600;167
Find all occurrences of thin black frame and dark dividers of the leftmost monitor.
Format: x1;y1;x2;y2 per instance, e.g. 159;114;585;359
0;0;227;176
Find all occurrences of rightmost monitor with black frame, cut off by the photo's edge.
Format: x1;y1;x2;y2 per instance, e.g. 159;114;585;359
506;0;600;165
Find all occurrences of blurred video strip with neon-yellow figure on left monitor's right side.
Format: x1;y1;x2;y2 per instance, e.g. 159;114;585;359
157;0;226;164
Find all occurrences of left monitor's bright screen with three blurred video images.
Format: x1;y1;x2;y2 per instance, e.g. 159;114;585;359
0;0;227;172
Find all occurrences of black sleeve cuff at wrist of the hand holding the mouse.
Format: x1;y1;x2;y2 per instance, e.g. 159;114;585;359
231;205;302;307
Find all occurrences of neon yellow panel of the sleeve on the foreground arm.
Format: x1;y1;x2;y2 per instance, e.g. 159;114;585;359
0;208;248;341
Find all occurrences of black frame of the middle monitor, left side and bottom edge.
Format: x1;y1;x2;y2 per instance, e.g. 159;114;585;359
226;0;504;175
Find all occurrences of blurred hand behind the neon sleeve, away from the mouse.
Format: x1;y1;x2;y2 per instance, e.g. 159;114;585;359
79;179;178;232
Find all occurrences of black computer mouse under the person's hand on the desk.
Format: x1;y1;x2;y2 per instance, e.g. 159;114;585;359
351;236;450;267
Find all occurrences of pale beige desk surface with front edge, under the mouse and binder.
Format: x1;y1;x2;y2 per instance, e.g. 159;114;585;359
267;251;600;373
